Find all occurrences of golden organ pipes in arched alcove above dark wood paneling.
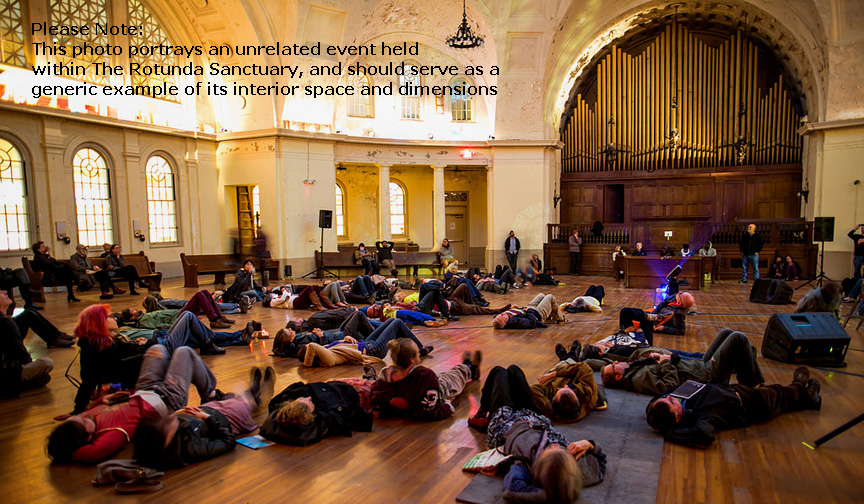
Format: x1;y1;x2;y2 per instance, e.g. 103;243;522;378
561;21;804;173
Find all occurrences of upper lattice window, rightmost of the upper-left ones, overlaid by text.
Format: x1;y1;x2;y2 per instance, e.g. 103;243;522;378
129;0;180;102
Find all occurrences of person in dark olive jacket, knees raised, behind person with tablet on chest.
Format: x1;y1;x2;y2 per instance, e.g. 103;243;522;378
600;329;765;395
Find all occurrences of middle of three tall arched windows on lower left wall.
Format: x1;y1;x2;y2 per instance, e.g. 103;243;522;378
72;147;114;246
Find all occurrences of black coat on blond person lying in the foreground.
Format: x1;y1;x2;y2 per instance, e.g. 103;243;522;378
260;382;372;446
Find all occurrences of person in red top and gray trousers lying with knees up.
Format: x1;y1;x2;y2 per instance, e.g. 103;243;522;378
48;345;240;464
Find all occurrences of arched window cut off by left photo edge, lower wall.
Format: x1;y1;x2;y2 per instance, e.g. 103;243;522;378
0;138;30;250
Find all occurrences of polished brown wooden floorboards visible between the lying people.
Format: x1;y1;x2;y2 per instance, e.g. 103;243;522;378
0;277;864;504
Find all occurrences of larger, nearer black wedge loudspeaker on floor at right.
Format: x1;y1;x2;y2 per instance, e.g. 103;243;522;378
762;313;851;366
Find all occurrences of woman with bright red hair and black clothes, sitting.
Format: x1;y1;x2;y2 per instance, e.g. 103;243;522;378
73;304;146;414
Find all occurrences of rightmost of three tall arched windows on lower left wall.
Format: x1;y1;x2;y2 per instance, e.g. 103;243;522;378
146;156;179;243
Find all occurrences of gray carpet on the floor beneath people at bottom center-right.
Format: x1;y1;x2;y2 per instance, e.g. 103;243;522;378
456;373;663;504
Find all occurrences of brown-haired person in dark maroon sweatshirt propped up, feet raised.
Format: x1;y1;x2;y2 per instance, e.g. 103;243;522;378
366;338;482;421
